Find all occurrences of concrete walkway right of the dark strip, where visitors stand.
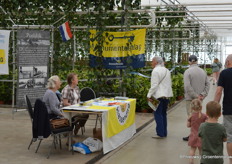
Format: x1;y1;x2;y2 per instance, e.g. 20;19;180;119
98;81;228;164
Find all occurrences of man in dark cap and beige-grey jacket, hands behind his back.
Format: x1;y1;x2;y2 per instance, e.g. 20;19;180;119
183;55;210;141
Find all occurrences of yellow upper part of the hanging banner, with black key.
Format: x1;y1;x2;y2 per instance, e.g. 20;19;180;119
90;29;146;57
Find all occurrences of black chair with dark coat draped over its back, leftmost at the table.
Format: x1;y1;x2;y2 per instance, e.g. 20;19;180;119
25;95;73;158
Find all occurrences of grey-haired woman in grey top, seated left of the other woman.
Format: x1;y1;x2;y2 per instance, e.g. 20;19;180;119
43;75;63;119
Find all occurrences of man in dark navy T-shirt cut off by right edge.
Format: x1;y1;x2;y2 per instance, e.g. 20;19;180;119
214;54;232;164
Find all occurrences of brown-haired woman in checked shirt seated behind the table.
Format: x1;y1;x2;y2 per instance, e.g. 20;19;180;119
61;73;89;135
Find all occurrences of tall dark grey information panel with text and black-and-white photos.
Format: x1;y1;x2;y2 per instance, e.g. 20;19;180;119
16;30;50;107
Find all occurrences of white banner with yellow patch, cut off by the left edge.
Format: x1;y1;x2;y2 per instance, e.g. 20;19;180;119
0;30;10;75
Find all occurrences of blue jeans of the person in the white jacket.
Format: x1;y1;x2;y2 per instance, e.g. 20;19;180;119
154;98;169;137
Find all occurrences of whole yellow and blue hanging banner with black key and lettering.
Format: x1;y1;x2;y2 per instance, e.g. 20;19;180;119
89;29;146;69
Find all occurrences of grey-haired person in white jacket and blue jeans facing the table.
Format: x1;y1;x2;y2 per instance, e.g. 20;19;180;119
147;56;173;139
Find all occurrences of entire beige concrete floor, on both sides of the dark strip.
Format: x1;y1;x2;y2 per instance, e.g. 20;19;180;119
0;77;228;164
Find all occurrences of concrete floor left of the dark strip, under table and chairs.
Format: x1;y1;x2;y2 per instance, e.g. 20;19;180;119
0;103;153;164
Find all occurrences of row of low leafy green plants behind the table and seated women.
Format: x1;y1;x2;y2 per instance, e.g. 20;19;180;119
54;66;184;111
